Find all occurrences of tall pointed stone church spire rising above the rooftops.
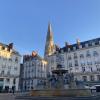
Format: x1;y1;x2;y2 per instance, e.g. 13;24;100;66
44;23;55;57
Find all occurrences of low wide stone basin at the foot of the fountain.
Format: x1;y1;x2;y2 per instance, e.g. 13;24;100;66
30;89;91;97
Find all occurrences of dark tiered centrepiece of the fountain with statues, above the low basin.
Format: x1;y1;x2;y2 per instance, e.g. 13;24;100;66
49;64;76;89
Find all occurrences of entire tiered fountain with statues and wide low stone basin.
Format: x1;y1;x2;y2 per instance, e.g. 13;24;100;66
30;65;91;97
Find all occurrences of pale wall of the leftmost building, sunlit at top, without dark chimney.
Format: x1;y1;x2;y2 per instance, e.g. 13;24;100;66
0;46;21;91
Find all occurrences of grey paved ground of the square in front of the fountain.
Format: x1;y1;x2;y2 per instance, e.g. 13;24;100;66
0;93;100;100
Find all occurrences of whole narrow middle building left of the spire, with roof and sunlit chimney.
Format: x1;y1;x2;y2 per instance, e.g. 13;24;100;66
23;52;47;91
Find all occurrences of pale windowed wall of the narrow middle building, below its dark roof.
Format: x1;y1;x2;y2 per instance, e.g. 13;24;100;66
23;56;47;91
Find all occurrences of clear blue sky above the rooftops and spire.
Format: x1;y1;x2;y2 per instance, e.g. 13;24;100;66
0;0;100;56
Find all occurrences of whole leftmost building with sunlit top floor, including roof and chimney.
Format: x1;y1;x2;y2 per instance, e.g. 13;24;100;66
0;43;21;92
